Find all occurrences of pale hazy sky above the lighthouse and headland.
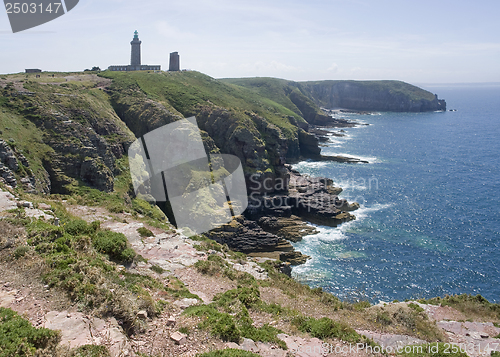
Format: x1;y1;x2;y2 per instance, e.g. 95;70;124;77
0;0;500;83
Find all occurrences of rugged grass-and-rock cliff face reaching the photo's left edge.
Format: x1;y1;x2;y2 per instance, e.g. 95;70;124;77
2;76;135;193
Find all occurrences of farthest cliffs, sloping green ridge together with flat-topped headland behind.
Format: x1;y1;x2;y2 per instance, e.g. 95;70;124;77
222;78;446;113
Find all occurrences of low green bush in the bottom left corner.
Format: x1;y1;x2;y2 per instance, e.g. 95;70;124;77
0;307;60;357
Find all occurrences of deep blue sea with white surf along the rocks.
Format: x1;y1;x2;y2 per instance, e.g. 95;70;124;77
293;85;500;302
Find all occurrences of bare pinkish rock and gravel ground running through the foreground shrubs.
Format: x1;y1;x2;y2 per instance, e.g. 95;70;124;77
0;190;500;357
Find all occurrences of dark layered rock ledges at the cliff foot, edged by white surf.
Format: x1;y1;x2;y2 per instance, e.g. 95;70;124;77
206;118;367;265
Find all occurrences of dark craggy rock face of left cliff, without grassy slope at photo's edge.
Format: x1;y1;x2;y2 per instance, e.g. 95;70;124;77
18;88;134;194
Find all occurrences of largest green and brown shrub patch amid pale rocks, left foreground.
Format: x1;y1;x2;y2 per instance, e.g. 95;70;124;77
11;219;168;333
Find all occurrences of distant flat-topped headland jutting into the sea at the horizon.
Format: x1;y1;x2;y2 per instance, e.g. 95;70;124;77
303;81;446;112
